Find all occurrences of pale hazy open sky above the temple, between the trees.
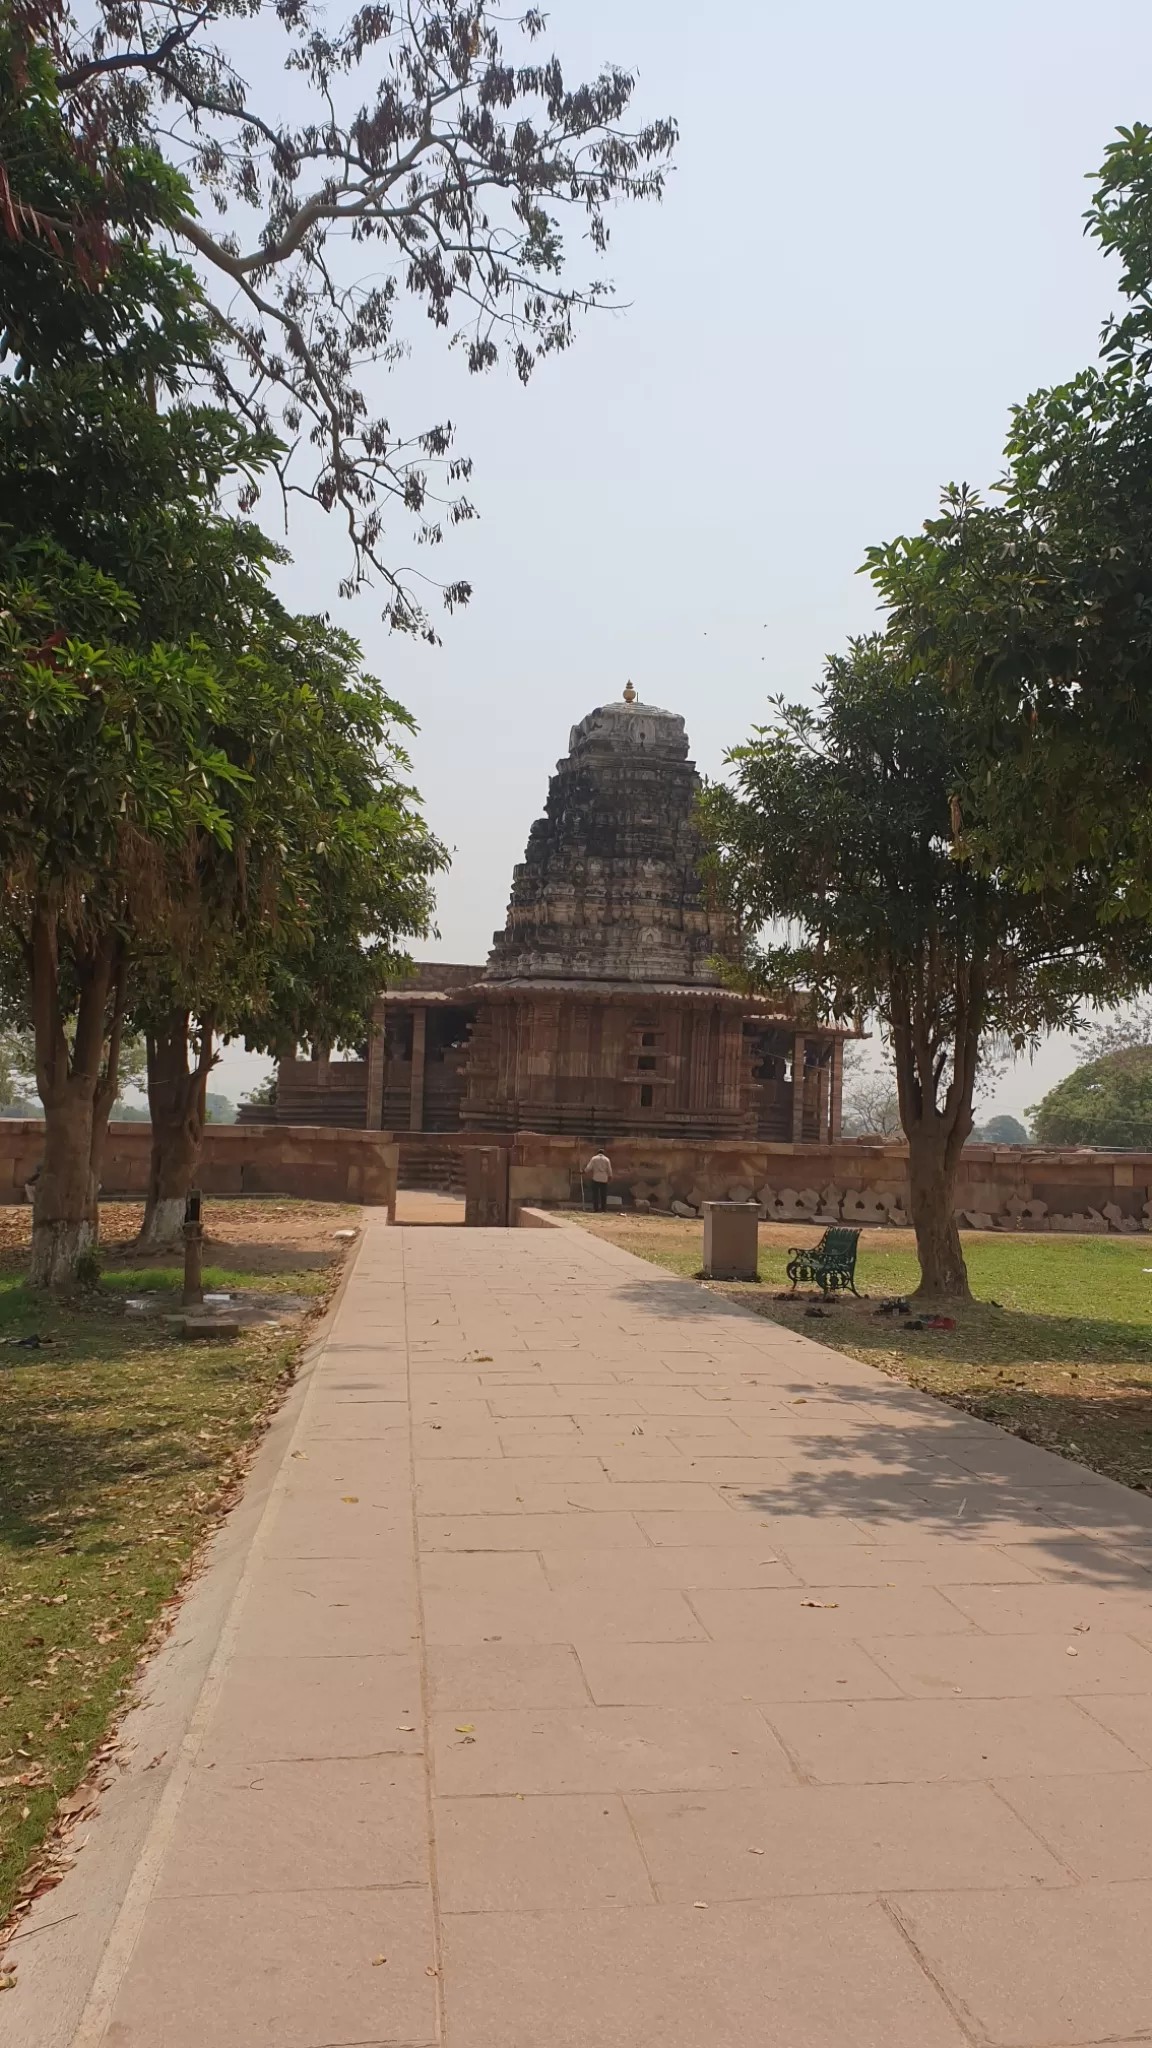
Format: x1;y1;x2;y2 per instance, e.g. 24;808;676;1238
208;0;1152;1110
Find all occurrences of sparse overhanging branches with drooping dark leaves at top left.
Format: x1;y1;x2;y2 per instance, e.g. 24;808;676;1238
31;0;674;631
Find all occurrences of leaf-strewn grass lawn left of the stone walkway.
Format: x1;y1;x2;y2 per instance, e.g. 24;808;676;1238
0;1204;348;1923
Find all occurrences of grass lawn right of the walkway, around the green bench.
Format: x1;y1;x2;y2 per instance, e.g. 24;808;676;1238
574;1217;1152;1491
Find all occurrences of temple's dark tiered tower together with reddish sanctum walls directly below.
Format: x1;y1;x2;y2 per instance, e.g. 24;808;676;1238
448;684;778;1137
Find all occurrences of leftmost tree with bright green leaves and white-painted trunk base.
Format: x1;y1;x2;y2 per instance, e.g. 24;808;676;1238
0;547;241;1286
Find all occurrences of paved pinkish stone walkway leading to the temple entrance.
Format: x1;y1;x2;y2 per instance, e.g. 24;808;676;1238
82;1223;1152;2048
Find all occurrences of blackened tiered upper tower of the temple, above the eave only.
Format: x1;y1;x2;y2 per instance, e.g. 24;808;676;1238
484;684;726;989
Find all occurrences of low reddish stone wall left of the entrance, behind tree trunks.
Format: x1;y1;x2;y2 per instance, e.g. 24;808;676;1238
0;1118;400;1208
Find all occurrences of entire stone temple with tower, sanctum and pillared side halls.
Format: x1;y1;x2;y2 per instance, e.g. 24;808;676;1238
262;684;853;1143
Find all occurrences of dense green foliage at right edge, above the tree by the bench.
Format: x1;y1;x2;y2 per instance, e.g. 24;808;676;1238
867;125;1152;905
